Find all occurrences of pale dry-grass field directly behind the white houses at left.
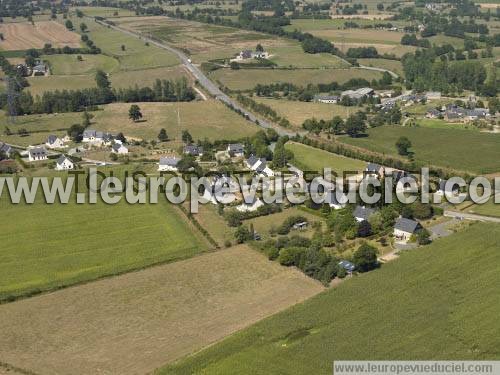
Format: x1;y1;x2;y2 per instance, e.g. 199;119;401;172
93;100;259;140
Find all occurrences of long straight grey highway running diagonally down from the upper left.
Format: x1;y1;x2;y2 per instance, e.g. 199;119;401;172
95;20;295;136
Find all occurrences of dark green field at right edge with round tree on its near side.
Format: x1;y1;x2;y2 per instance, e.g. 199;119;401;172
339;126;500;173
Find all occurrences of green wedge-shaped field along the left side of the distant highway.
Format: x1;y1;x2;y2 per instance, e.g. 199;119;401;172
86;20;180;70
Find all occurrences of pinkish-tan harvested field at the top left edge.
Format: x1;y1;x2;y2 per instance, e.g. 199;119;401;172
0;21;80;51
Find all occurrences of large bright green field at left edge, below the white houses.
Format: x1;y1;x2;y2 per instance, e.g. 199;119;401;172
0;174;208;302
